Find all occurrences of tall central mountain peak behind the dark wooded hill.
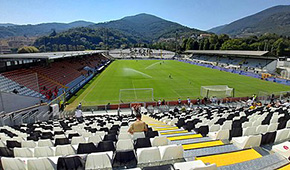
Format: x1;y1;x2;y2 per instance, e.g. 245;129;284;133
90;13;205;42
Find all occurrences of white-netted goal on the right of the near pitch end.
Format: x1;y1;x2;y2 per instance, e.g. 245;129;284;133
200;85;234;98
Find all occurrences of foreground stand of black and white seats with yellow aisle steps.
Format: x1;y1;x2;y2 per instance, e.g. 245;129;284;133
0;101;290;170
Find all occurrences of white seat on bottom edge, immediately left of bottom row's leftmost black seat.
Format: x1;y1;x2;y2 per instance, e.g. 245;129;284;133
27;158;56;170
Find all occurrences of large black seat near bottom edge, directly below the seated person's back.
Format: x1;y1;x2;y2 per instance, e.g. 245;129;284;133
112;150;137;168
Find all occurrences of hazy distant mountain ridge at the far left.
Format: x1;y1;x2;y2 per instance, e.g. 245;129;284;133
0;21;94;38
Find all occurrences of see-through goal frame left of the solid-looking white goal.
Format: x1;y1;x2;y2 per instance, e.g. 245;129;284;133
119;88;154;103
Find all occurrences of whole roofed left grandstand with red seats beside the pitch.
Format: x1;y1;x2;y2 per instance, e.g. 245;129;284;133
0;51;109;112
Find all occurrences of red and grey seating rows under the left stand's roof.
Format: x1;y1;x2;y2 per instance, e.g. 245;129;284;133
0;55;108;99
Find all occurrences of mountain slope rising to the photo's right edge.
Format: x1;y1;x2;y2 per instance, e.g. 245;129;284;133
217;5;290;37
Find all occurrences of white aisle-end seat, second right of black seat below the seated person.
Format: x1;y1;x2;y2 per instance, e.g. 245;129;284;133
159;145;184;161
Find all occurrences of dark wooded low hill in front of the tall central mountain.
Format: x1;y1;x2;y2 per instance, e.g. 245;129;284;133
34;27;141;51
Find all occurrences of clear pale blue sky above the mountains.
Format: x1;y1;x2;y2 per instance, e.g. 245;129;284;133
0;0;290;30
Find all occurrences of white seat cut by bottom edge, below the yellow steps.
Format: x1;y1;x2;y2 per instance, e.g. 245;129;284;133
174;160;217;170
